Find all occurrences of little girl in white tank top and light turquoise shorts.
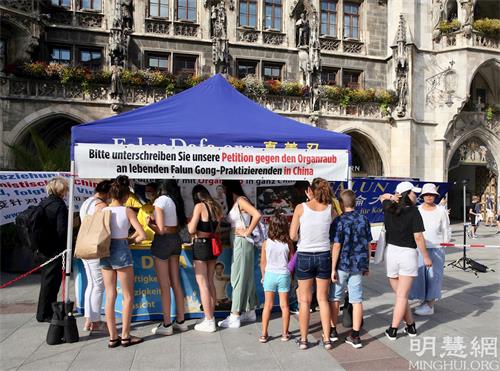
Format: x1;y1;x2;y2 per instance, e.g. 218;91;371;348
259;211;293;343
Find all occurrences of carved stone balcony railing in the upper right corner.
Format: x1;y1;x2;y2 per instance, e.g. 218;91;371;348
434;30;500;50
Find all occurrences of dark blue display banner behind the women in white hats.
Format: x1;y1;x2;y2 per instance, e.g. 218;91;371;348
332;178;449;223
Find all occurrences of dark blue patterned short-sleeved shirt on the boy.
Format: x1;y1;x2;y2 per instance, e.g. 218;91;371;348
333;211;372;273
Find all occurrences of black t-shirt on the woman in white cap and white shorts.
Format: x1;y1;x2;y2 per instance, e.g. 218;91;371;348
382;200;425;249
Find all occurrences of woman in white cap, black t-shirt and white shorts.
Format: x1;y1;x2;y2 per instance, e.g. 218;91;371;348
380;182;432;340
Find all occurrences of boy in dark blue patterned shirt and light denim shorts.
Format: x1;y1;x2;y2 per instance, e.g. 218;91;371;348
329;189;372;348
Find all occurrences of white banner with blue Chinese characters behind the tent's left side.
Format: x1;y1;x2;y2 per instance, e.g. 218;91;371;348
0;171;97;225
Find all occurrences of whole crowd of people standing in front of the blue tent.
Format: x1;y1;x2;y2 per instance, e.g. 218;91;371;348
37;176;458;349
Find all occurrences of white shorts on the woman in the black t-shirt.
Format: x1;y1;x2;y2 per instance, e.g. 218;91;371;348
385;244;418;278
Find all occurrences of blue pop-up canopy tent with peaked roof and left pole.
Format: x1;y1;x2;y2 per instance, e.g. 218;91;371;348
66;75;351;300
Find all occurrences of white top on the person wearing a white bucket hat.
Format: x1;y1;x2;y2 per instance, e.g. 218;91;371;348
418;205;451;248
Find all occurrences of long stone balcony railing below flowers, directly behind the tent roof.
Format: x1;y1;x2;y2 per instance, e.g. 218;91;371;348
0;77;387;119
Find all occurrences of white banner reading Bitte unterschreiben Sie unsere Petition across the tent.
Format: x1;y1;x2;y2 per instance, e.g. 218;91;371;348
74;143;349;181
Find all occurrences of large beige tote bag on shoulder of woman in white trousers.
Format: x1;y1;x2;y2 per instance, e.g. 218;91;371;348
75;205;111;259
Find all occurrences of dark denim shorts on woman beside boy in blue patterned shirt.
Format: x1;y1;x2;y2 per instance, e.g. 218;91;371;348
295;250;332;280
